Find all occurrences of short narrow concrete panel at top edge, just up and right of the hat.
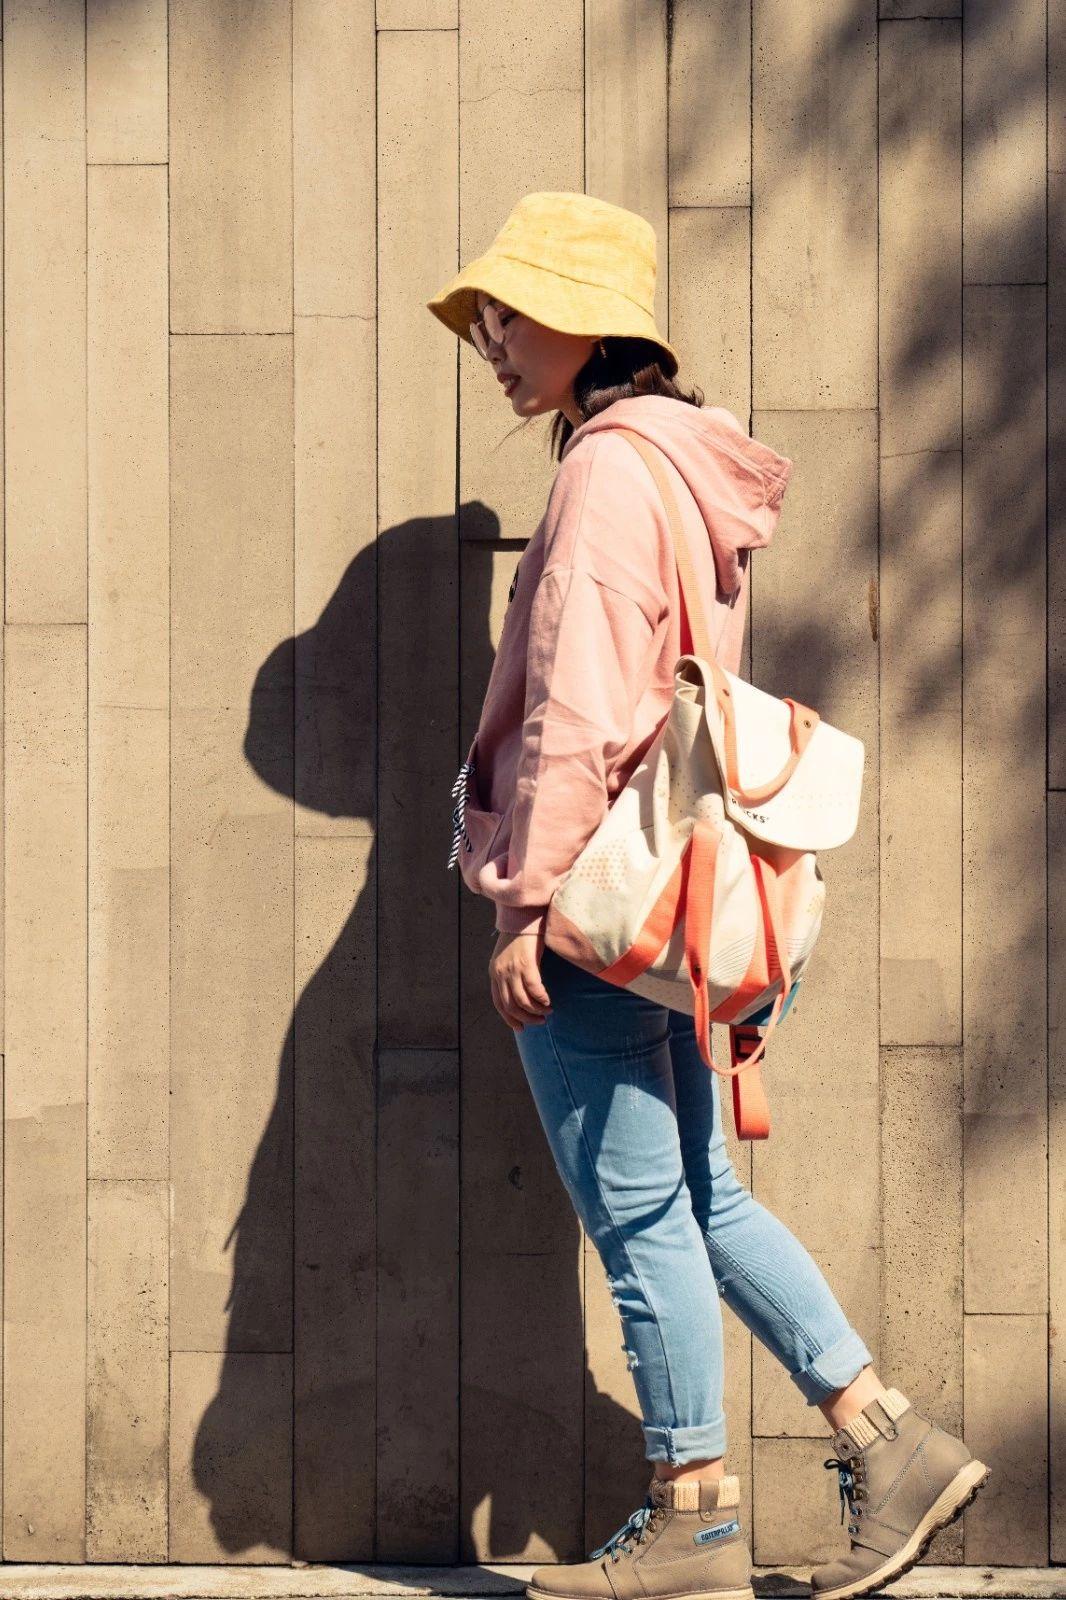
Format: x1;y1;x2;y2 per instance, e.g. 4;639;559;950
667;0;751;209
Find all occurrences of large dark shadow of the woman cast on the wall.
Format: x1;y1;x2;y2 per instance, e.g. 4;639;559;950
192;504;650;1563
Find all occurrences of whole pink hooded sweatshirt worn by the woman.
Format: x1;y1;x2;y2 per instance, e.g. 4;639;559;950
448;395;792;933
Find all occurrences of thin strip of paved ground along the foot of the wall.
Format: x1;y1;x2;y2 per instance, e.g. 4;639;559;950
0;1562;1066;1600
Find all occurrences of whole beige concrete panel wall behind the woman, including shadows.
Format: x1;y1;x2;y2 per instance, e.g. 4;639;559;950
0;0;1066;1565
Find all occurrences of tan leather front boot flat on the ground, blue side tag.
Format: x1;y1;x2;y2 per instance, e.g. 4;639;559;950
525;1472;755;1600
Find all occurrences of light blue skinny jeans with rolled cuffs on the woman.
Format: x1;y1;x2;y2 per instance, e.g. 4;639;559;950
514;947;874;1466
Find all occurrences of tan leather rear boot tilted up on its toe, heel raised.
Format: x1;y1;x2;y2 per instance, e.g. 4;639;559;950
810;1389;991;1600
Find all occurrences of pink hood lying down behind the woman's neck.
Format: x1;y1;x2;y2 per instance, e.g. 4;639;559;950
560;395;792;600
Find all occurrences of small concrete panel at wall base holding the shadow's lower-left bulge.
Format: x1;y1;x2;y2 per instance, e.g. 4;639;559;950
170;1350;293;1566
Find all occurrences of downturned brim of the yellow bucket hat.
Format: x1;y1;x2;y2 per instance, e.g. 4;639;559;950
426;251;679;376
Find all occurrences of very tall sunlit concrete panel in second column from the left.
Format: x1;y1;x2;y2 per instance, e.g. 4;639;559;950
88;165;170;1178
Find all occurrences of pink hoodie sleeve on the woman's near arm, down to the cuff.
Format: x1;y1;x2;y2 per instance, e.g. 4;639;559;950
479;438;656;933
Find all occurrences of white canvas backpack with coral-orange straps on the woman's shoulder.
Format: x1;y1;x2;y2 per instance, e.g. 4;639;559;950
544;429;864;1139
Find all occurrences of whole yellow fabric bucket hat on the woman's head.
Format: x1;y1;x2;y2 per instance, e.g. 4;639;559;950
426;189;679;378
